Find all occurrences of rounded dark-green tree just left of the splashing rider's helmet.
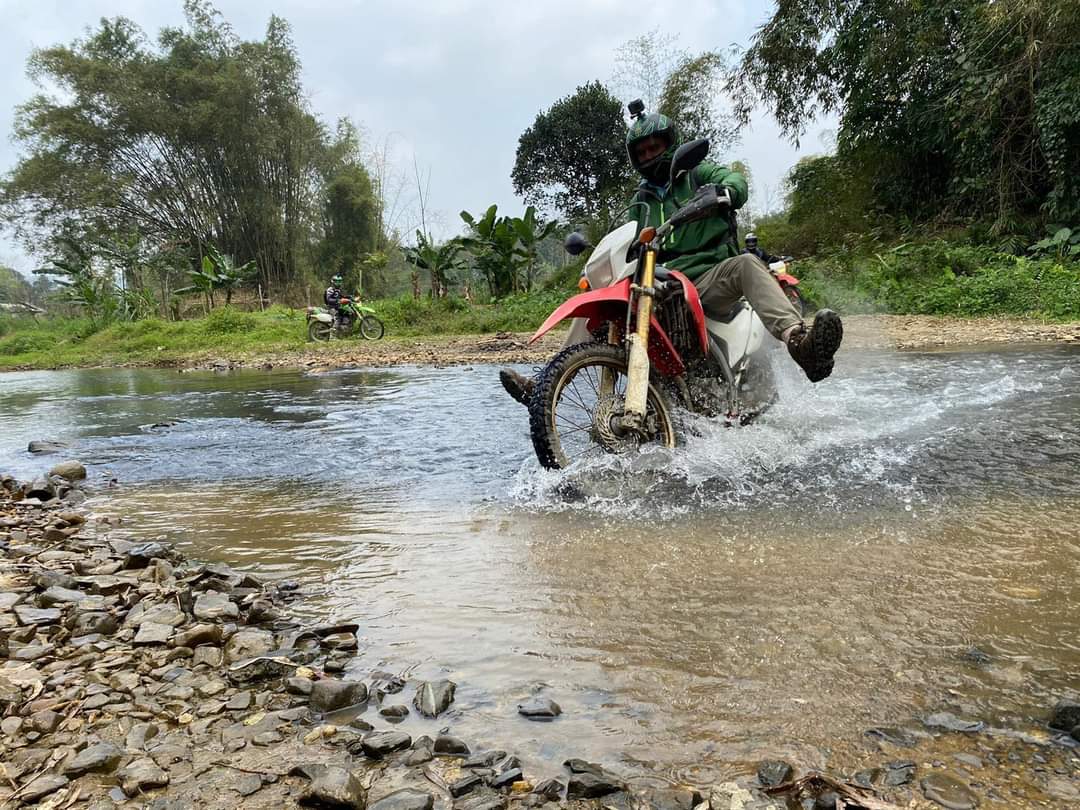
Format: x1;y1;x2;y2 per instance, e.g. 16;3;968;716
511;82;633;228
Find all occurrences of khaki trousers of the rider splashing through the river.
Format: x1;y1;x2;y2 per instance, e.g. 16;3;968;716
563;254;802;349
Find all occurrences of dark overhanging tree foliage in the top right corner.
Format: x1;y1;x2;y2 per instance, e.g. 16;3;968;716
731;0;1080;234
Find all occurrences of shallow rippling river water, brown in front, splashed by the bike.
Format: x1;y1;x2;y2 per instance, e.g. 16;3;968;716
0;348;1080;783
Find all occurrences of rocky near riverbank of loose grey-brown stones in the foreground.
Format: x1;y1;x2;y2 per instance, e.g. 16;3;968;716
0;462;1080;810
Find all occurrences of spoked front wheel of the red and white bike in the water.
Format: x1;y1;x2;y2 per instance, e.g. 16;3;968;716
529;343;675;470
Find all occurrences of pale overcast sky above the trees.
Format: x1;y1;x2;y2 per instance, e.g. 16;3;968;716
0;0;825;271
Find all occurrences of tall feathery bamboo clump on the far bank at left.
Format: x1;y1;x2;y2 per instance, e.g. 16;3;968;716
0;0;376;299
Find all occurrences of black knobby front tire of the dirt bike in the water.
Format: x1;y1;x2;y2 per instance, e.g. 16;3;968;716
529;342;675;470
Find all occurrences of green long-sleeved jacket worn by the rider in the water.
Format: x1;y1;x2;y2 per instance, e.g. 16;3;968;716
631;161;747;279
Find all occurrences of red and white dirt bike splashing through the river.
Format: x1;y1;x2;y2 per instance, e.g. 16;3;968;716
529;139;773;469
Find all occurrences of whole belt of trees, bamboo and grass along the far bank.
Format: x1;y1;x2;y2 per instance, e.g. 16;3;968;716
0;0;1080;367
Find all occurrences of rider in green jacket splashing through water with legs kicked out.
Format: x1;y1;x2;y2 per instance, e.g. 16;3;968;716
499;112;843;405
